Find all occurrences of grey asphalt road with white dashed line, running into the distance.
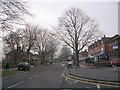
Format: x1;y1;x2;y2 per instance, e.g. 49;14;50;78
2;63;119;90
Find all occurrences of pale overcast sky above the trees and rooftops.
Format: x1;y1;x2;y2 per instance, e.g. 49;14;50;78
0;0;118;58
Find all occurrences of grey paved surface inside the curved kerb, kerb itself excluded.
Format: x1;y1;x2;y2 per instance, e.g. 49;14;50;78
67;67;120;82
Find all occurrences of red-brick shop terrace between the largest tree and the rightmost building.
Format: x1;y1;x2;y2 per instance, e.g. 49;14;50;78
88;36;111;61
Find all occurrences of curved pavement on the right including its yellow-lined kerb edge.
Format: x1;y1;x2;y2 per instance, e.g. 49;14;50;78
64;64;120;86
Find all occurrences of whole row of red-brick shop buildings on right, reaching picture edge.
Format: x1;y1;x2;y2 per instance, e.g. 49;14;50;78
88;34;120;61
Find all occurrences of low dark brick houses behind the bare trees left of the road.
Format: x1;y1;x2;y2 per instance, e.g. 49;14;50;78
5;47;39;63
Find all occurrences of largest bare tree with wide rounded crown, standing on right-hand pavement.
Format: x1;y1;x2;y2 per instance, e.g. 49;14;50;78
56;8;101;66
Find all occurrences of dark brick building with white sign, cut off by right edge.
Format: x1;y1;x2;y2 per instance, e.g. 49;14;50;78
109;35;120;60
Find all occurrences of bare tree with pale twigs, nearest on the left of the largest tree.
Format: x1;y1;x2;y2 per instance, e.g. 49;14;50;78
34;28;56;64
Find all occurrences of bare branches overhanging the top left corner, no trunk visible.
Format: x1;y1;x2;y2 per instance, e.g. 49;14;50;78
0;0;31;31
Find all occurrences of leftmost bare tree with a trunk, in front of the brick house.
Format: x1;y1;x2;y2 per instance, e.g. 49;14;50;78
4;32;22;63
